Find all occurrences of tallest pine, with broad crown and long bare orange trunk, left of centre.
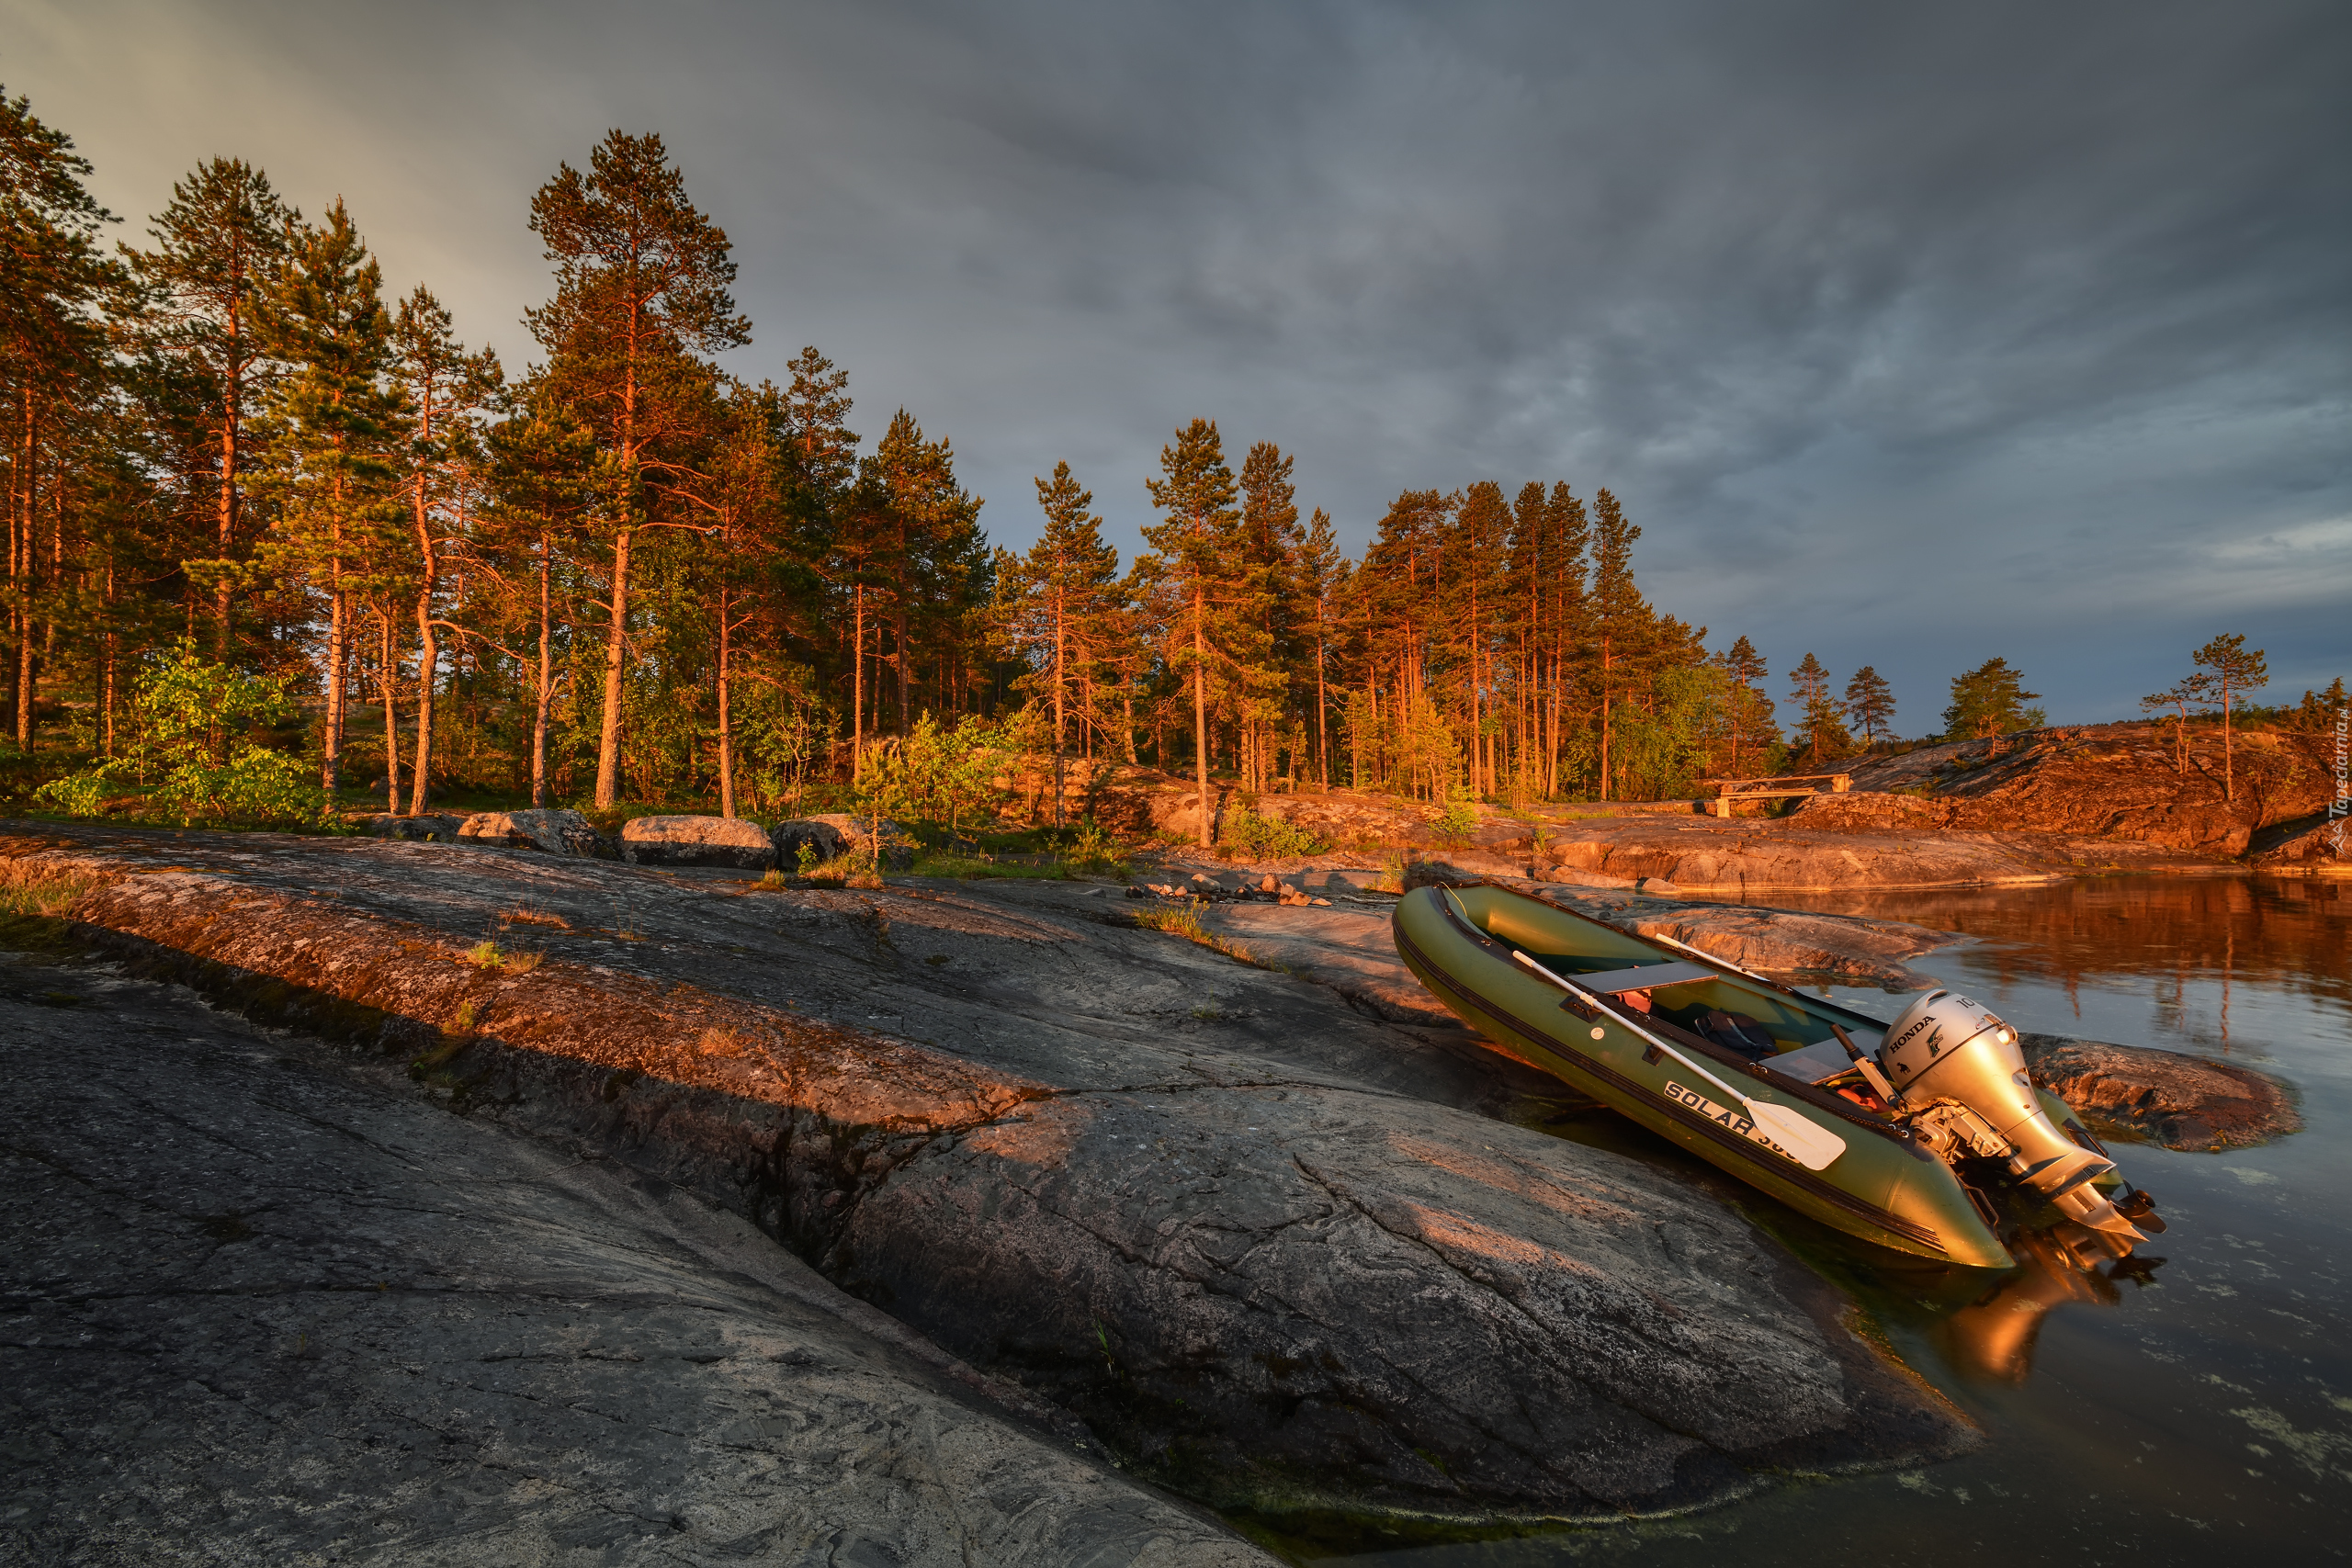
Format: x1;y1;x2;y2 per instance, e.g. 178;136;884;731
526;131;751;811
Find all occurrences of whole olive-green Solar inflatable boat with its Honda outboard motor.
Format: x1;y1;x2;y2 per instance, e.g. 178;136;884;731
1395;884;2159;1267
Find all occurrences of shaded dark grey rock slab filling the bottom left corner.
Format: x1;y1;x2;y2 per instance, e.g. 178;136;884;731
0;959;1270;1568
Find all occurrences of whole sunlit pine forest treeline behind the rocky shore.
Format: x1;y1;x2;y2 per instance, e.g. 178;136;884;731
0;94;2324;831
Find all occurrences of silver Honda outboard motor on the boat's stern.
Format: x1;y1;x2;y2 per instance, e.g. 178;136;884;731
1877;989;2147;1258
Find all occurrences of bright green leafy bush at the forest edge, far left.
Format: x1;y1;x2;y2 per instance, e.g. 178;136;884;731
40;642;334;828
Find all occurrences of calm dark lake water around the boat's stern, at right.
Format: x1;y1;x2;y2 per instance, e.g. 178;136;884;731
1291;877;2352;1568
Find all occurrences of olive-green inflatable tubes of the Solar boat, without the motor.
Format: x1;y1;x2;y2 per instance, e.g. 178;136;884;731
1395;886;2013;1269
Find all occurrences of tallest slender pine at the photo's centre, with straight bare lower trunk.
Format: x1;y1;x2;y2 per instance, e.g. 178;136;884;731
1143;419;1242;849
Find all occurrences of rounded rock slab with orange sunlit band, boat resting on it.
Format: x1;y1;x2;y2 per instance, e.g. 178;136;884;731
0;825;1973;1532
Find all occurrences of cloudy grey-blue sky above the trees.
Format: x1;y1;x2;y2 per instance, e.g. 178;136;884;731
14;0;2352;733
